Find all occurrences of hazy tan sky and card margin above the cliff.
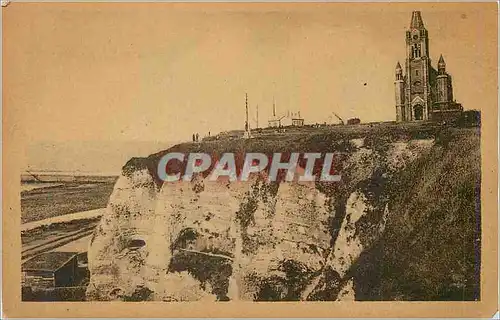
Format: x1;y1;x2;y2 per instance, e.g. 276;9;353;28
3;2;497;172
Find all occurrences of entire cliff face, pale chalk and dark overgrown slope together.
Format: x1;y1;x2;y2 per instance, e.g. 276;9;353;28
87;127;480;301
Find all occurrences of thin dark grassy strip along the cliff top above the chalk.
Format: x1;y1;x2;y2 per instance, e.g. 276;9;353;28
122;122;479;185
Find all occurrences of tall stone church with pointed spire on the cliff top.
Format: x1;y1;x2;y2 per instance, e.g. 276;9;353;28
394;11;463;121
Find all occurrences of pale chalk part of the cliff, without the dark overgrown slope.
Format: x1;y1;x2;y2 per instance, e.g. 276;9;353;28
87;127;480;301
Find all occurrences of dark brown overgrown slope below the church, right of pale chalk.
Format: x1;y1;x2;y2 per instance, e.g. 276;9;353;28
351;129;481;300
